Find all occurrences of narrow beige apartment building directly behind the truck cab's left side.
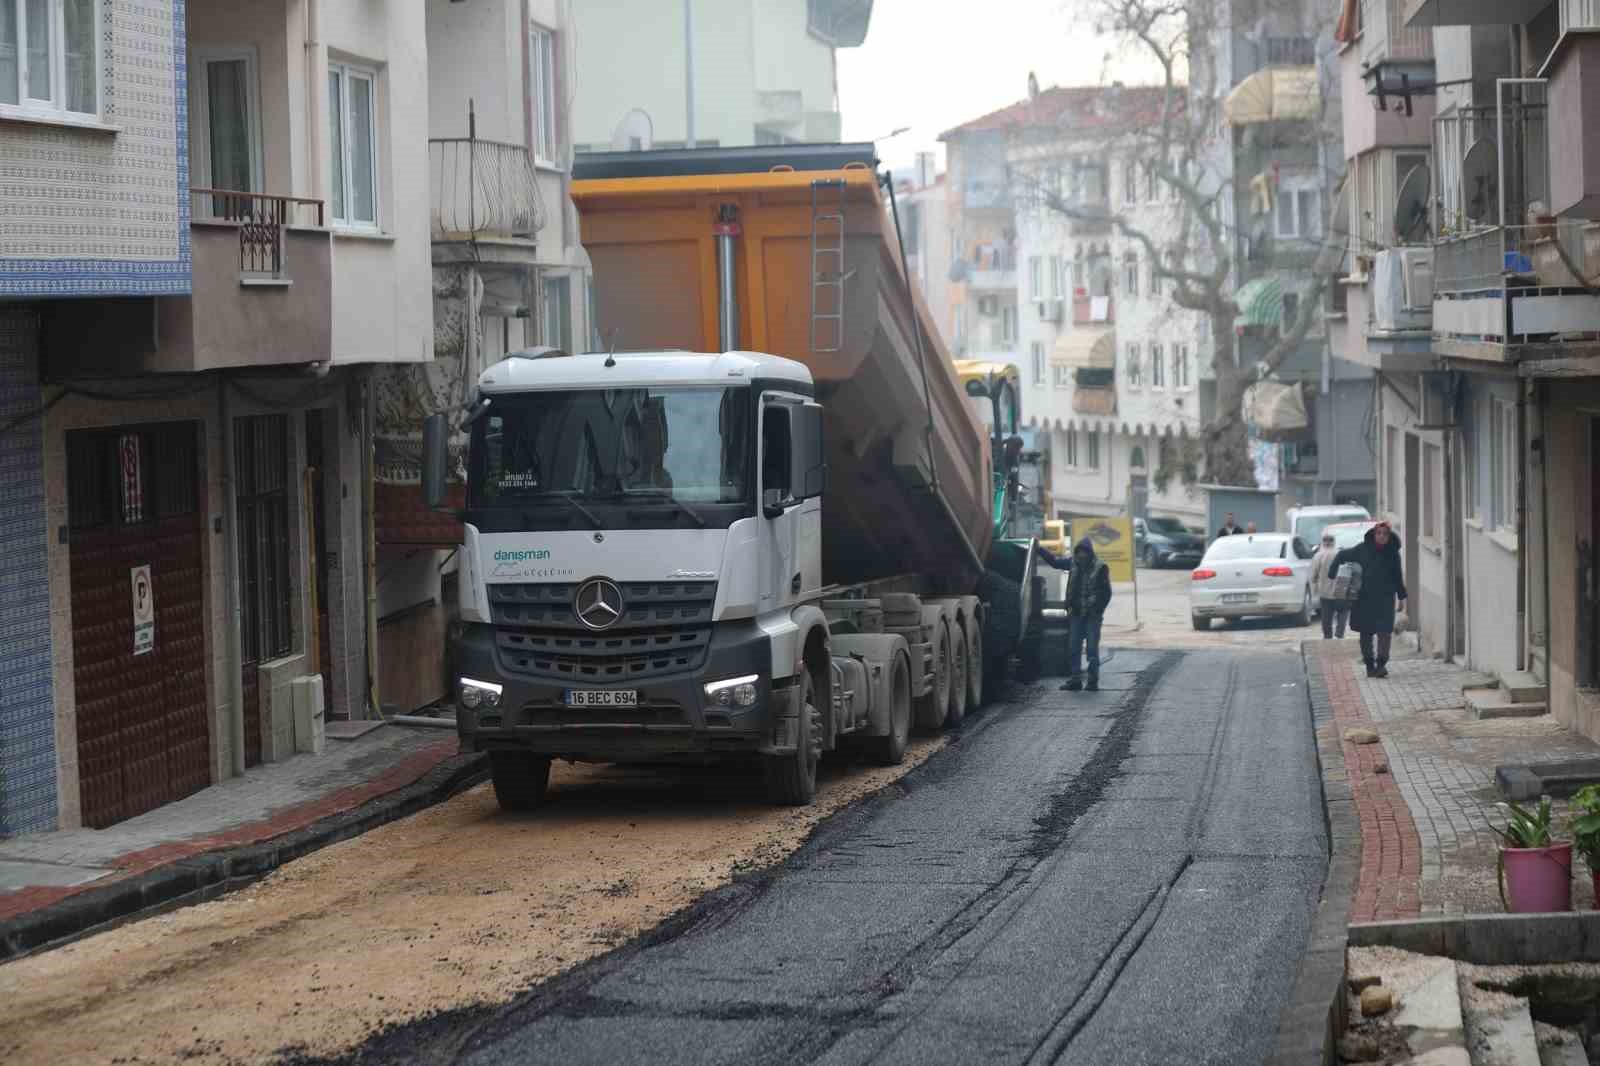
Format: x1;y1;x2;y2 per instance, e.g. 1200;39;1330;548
373;0;603;714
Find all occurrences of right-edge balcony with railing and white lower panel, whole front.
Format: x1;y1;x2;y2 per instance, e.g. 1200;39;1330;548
1434;221;1600;362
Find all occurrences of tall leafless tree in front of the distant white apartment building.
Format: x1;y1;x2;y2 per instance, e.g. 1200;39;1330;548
1013;0;1328;485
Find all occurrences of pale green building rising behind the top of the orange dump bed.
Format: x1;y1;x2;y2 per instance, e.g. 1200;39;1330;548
562;0;872;152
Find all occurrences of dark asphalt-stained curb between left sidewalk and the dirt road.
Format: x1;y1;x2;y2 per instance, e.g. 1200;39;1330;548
0;752;488;964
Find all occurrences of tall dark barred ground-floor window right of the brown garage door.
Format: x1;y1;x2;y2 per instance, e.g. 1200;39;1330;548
234;415;293;663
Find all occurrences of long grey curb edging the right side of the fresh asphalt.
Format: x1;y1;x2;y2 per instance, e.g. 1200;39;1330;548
1267;643;1362;1066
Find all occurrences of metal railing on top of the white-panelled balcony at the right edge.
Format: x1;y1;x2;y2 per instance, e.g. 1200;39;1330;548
1434;221;1600;293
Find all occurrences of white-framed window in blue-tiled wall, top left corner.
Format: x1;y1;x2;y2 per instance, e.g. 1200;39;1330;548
0;0;101;118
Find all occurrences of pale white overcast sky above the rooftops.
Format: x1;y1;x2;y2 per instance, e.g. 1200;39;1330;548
838;0;1158;170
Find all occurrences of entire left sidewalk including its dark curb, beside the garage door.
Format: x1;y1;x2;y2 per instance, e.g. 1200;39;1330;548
0;723;482;959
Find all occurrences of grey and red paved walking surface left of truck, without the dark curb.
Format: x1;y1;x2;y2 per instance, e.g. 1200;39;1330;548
0;725;458;922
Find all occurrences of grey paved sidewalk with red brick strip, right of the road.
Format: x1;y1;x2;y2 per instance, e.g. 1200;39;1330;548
1306;640;1600;922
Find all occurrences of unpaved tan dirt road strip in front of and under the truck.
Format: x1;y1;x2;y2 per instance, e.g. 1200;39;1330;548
0;738;944;1066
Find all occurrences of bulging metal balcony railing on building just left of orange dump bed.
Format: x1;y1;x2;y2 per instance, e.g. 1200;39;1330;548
427;138;546;240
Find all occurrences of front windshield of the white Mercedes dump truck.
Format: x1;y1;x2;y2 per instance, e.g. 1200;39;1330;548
467;389;754;525
